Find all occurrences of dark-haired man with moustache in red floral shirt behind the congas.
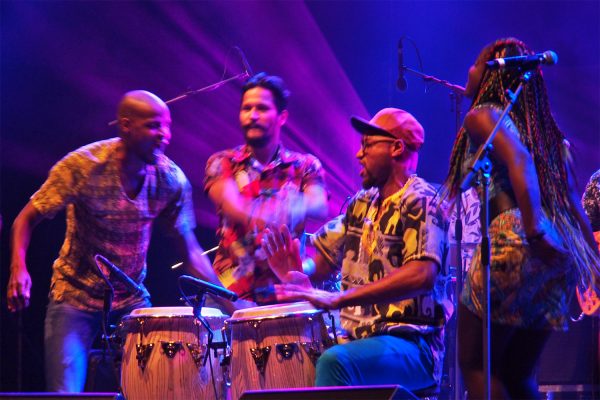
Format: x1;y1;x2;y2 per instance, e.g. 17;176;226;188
204;73;327;308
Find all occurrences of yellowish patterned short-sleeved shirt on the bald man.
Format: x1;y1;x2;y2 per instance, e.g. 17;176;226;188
31;138;195;311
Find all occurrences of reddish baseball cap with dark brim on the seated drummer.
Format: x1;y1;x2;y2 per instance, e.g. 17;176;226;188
350;108;425;151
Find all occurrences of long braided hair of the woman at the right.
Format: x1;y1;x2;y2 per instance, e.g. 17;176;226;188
441;38;599;285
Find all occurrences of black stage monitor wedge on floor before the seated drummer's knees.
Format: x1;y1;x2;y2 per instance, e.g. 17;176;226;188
240;385;418;400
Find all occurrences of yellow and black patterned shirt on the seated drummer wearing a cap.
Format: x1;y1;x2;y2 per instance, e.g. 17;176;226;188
314;176;450;381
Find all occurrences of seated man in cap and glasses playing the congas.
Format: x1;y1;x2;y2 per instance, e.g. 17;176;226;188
265;108;448;390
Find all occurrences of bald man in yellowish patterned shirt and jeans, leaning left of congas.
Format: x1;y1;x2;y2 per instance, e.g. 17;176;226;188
7;90;217;392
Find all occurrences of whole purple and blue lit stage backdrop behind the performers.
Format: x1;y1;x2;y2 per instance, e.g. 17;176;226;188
0;1;600;391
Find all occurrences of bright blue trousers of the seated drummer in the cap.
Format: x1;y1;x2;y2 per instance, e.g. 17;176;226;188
316;335;436;390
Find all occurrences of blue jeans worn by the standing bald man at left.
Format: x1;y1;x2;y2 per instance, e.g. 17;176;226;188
44;300;145;392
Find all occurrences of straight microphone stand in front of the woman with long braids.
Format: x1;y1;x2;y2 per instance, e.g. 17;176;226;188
459;71;532;400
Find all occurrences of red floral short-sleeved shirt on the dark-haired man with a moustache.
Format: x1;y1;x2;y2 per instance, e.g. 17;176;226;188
204;145;325;300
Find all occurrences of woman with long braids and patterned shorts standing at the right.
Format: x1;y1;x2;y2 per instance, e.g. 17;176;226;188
443;38;600;399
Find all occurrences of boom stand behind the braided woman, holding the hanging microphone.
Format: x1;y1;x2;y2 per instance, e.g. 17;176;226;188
400;65;465;400
